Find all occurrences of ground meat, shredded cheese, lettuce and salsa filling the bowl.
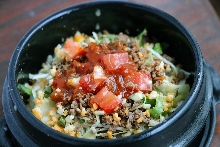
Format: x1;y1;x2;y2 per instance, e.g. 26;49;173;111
19;30;190;139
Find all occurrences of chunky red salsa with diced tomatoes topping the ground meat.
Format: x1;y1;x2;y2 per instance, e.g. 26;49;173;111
50;39;152;113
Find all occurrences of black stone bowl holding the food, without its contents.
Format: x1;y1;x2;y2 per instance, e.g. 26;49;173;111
3;1;219;147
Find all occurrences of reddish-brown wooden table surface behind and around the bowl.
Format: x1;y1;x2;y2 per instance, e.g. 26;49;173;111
0;0;220;147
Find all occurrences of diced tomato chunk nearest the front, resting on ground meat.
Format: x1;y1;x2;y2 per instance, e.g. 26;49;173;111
90;87;121;114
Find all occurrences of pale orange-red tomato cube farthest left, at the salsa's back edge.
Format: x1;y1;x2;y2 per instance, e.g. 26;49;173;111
64;39;85;59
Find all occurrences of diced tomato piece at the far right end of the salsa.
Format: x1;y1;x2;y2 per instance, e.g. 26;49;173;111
124;72;152;91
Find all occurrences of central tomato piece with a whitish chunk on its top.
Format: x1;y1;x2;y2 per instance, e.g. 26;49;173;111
79;66;106;92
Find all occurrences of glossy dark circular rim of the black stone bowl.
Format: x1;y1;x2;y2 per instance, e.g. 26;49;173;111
8;1;204;143
